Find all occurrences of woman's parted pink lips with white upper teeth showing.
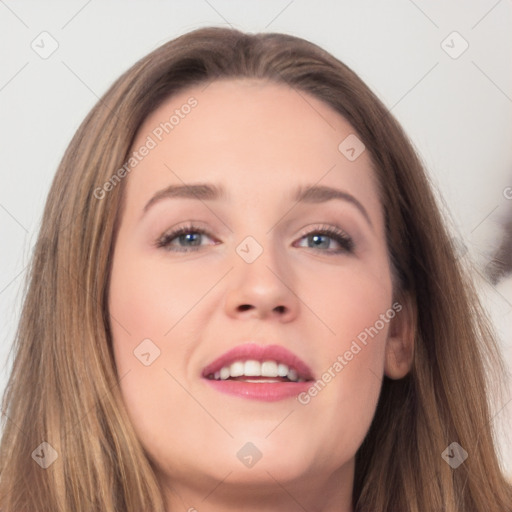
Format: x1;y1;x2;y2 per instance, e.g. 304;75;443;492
202;343;313;401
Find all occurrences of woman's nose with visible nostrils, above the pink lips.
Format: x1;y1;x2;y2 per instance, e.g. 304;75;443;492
225;239;300;322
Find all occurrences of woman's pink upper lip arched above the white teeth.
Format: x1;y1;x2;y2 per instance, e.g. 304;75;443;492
202;342;313;380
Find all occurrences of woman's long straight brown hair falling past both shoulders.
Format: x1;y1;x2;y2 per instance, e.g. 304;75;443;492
0;28;512;512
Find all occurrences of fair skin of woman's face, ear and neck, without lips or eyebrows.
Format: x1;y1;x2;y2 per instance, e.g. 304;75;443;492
109;80;413;512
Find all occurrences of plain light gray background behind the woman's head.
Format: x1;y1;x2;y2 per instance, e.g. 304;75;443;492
0;0;512;476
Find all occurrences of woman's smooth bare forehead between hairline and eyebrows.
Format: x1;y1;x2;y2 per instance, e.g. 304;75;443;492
124;79;376;221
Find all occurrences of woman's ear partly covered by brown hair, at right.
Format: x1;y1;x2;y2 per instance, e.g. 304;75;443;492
384;293;417;379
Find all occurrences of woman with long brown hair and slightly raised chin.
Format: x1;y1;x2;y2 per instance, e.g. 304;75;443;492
0;28;512;512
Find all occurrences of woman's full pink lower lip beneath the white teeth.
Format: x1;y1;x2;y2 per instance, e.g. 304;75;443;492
205;379;311;402
